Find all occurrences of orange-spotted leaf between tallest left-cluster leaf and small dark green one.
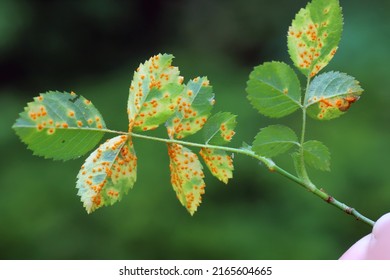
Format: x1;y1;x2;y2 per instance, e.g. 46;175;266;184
167;77;215;139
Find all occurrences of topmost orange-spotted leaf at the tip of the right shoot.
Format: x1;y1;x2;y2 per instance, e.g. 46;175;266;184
287;0;343;77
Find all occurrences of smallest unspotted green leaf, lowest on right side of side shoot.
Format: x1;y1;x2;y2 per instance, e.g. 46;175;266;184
302;140;330;171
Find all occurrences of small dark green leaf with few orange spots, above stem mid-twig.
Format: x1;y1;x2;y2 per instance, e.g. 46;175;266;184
203;112;237;145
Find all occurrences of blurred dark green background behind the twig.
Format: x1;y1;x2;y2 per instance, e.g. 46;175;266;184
0;0;390;259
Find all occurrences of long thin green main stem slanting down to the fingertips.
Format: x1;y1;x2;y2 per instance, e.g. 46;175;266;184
128;132;375;227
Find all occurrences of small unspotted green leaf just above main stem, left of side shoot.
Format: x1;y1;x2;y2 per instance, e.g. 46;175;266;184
252;125;299;157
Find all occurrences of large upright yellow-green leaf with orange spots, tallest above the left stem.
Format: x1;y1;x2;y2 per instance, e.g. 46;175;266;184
127;54;183;131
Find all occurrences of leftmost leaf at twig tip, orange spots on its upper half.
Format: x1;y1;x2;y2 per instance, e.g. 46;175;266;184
13;91;106;160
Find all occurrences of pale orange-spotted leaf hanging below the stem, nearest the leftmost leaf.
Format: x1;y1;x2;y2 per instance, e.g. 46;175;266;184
76;135;137;213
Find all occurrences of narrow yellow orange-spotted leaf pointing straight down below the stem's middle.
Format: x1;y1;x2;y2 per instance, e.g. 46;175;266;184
168;144;206;215
